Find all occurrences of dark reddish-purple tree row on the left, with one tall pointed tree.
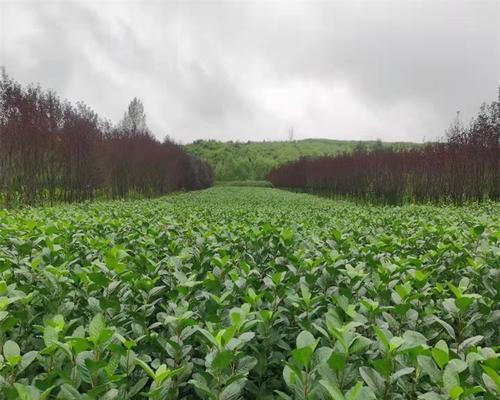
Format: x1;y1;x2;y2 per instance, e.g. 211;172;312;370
0;70;213;206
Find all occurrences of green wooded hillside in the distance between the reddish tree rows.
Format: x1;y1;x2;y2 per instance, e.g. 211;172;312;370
186;139;415;181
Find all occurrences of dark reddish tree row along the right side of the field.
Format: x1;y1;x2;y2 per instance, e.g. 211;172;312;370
268;88;500;204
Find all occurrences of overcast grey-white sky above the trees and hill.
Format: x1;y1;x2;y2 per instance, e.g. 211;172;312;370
0;0;500;143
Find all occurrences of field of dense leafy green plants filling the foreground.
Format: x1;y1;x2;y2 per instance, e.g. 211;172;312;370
0;187;500;400
